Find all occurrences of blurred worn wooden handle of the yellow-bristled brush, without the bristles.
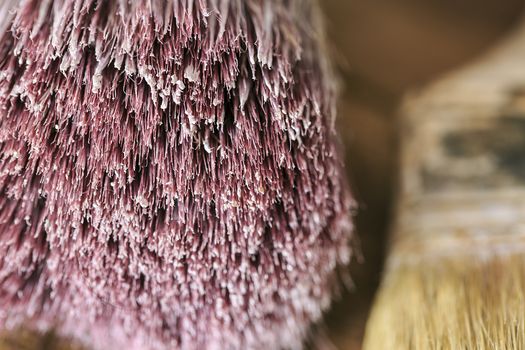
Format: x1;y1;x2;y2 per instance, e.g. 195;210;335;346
393;19;525;259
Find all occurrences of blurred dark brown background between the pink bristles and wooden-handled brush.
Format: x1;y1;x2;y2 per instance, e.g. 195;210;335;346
320;0;525;350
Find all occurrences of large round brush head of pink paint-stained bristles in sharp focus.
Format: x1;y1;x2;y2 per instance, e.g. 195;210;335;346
0;0;352;349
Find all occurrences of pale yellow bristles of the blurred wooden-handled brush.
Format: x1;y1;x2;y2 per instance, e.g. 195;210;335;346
364;255;525;350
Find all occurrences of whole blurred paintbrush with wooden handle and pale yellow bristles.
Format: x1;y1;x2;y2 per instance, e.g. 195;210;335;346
364;19;525;350
